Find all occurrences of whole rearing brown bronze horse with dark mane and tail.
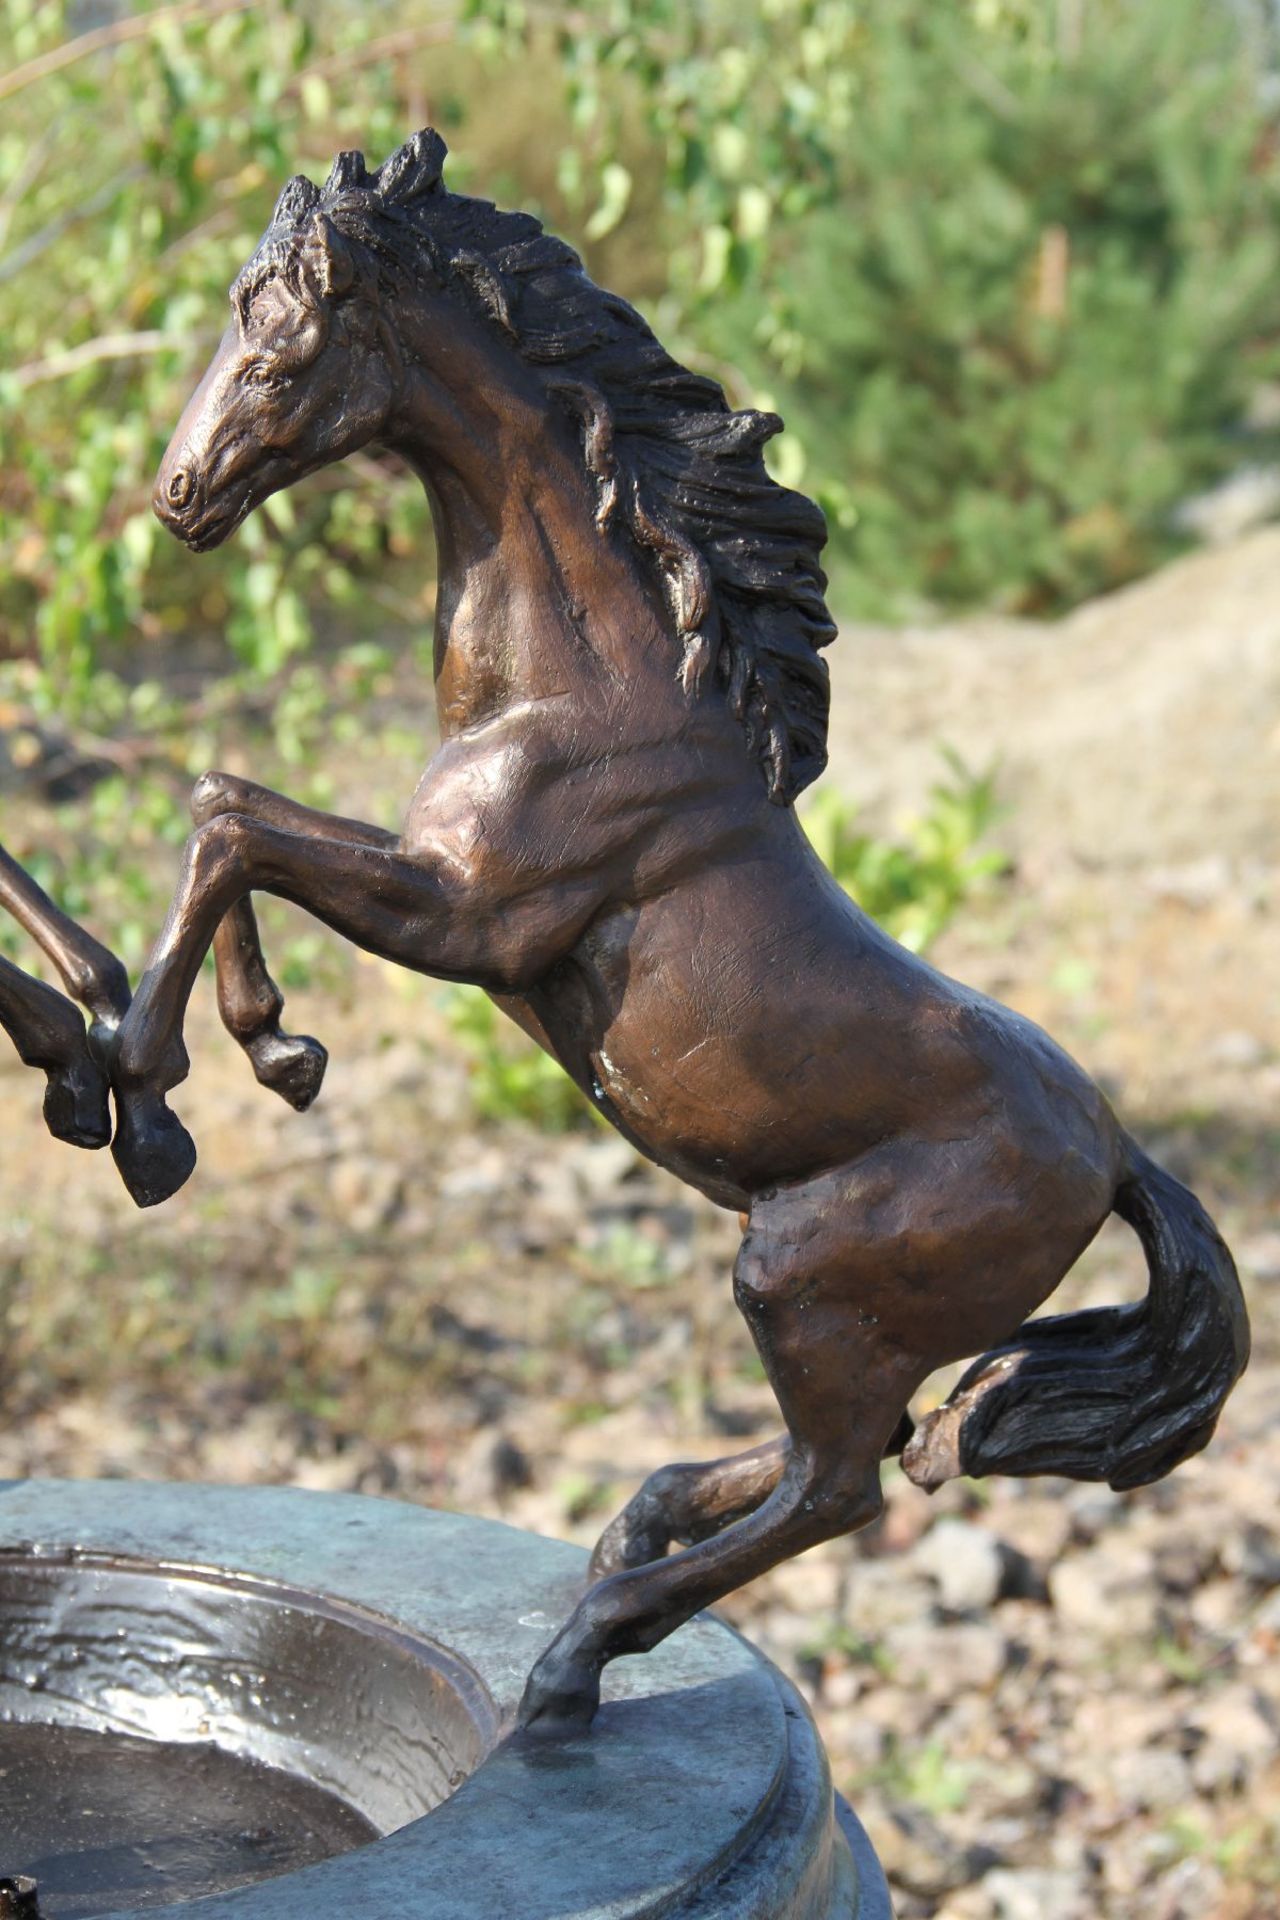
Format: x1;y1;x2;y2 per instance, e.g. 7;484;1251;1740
113;131;1247;1728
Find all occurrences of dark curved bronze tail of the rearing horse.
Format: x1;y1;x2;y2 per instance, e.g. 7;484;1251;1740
902;1135;1249;1490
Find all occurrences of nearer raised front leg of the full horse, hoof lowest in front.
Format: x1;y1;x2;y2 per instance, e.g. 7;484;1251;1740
113;814;597;1206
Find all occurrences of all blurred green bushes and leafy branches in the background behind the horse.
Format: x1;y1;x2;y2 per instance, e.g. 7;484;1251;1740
0;0;1280;1082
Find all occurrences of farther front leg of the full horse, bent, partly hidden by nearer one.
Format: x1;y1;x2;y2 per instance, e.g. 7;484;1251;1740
192;774;395;1114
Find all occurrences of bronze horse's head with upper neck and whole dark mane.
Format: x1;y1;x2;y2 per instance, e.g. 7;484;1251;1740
154;129;835;804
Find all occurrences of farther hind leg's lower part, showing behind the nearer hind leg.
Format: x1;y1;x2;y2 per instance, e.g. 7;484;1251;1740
591;1434;791;1580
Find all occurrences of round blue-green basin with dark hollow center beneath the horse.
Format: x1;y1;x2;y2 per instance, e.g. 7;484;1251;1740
0;1480;890;1920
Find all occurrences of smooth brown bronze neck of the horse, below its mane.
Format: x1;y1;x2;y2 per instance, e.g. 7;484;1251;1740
390;303;676;733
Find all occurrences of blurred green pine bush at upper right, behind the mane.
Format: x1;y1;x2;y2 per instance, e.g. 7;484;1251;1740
495;0;1280;612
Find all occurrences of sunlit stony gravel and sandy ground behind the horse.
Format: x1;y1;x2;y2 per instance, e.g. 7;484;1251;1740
0;532;1280;1920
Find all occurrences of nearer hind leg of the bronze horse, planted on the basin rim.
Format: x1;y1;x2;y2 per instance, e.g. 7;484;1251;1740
520;1175;931;1732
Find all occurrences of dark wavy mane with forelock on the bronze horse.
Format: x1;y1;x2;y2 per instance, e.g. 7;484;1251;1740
242;129;835;803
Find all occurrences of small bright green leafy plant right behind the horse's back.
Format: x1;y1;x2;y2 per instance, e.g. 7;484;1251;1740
802;749;1009;952
